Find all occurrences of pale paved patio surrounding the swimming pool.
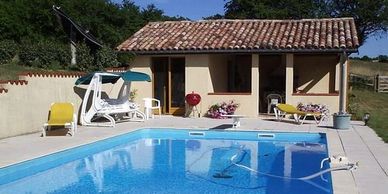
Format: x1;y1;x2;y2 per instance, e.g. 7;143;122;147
0;116;388;194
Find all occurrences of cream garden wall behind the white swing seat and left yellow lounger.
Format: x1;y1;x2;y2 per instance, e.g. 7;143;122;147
0;73;127;138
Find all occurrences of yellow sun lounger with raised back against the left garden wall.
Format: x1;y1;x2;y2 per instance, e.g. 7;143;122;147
42;102;77;137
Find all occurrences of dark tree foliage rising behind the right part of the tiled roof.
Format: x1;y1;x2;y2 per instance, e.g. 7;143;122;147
221;0;388;44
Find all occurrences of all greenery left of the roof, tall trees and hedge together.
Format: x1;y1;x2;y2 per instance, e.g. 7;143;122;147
0;0;186;70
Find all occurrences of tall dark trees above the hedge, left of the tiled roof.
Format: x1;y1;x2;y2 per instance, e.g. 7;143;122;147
0;0;183;47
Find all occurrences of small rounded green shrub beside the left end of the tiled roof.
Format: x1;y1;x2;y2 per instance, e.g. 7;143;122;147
96;47;120;69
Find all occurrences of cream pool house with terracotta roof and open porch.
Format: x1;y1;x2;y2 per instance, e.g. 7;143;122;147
117;18;359;117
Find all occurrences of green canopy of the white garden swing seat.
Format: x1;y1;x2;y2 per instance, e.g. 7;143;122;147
75;71;151;85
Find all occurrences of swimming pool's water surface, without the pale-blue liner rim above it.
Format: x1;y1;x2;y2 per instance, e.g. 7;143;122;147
0;139;331;194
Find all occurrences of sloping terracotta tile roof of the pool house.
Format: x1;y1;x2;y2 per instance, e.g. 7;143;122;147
117;18;359;53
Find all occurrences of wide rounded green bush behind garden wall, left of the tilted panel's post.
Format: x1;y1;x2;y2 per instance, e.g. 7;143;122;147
19;41;70;69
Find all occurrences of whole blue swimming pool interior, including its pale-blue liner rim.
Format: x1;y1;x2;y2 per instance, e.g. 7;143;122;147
0;129;332;194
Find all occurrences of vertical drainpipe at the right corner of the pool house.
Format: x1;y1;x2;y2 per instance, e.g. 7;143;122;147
338;52;348;115
